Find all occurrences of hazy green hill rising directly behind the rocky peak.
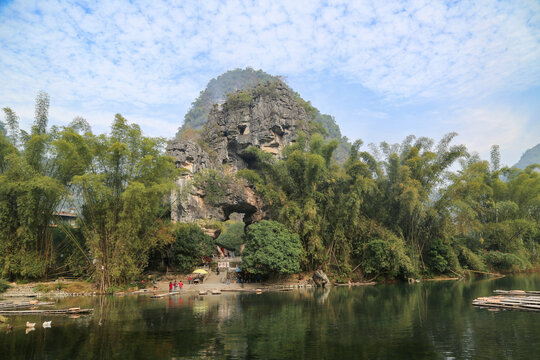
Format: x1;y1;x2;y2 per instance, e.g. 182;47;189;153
176;67;351;162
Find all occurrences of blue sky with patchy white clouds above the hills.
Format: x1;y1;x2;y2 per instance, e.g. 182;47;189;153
0;0;540;165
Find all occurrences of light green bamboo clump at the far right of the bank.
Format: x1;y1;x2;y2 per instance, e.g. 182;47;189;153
444;156;540;270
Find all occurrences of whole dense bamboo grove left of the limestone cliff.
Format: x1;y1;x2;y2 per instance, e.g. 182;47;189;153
0;93;181;289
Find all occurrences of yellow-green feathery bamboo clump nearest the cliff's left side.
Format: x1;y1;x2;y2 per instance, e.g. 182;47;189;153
73;114;176;290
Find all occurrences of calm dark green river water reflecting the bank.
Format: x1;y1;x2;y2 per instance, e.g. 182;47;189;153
0;274;540;360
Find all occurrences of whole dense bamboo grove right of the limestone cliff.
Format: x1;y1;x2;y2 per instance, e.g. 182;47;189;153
239;134;540;278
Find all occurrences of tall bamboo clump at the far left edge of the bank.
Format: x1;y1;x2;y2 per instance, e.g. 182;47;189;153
0;92;77;279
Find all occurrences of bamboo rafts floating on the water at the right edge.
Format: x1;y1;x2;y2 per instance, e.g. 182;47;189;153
473;290;540;311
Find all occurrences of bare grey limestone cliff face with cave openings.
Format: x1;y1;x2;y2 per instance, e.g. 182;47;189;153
167;81;309;229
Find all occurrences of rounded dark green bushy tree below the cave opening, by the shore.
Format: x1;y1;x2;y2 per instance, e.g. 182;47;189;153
242;220;302;274
